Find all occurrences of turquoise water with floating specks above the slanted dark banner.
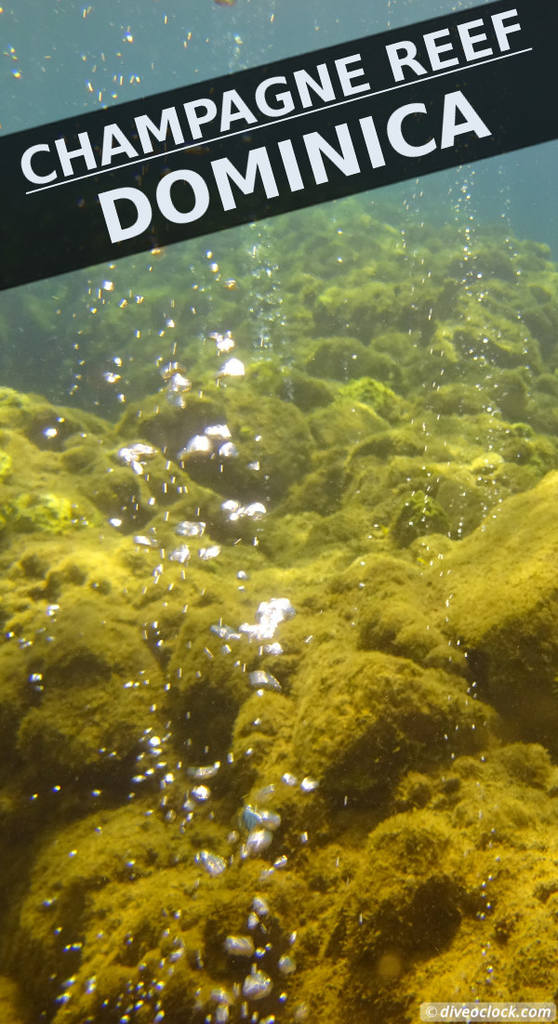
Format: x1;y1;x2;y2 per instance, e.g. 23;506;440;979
2;0;474;131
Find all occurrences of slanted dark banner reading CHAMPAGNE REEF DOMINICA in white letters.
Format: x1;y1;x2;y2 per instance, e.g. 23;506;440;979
0;0;558;288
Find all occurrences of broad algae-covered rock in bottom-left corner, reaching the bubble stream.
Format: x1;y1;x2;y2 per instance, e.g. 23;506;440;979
9;790;303;1024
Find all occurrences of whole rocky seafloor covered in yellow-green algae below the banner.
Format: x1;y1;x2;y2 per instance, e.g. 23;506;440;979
0;200;558;1024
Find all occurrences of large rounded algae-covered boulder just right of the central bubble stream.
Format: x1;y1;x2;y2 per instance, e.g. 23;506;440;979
294;652;488;804
